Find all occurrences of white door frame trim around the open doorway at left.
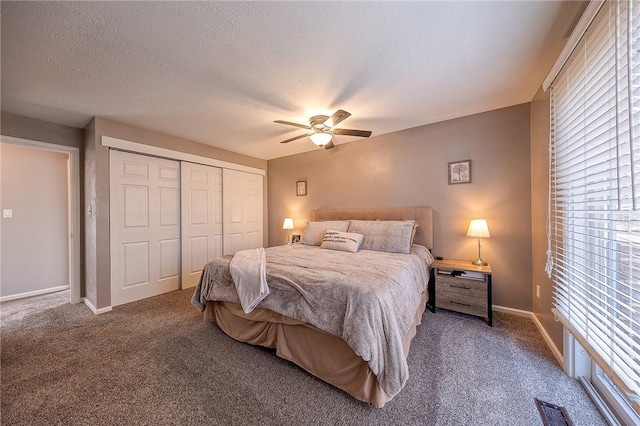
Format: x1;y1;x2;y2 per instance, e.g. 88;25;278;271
0;136;82;303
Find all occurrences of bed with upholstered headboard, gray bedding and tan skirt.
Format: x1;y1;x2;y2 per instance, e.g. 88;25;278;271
192;207;435;408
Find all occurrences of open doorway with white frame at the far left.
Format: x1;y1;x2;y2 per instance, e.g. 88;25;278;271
0;136;81;303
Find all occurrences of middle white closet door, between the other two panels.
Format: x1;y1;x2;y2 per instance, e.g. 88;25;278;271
180;162;222;288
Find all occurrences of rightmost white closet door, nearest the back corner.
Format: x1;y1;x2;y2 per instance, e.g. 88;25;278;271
222;169;263;254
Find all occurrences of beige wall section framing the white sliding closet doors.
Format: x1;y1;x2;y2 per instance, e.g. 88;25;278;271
84;117;268;309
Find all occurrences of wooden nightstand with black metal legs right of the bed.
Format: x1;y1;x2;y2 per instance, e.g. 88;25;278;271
431;260;493;327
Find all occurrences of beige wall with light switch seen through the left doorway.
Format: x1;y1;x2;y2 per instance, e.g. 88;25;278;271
0;144;69;297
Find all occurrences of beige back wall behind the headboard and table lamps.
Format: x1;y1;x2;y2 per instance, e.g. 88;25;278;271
268;104;532;311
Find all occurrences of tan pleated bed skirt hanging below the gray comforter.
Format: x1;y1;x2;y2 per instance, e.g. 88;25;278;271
205;292;427;408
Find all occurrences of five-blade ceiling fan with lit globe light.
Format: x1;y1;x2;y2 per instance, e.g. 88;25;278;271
274;109;371;149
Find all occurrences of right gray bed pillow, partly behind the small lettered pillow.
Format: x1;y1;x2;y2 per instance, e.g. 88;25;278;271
349;220;415;254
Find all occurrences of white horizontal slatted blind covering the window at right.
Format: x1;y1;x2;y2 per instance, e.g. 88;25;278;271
547;0;640;412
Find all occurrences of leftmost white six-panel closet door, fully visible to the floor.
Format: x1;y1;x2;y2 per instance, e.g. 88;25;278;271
109;150;180;306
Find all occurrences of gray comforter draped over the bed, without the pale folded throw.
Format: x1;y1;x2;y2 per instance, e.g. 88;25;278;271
192;244;433;398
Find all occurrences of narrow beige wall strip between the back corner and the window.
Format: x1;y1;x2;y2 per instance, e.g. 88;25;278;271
531;89;562;352
